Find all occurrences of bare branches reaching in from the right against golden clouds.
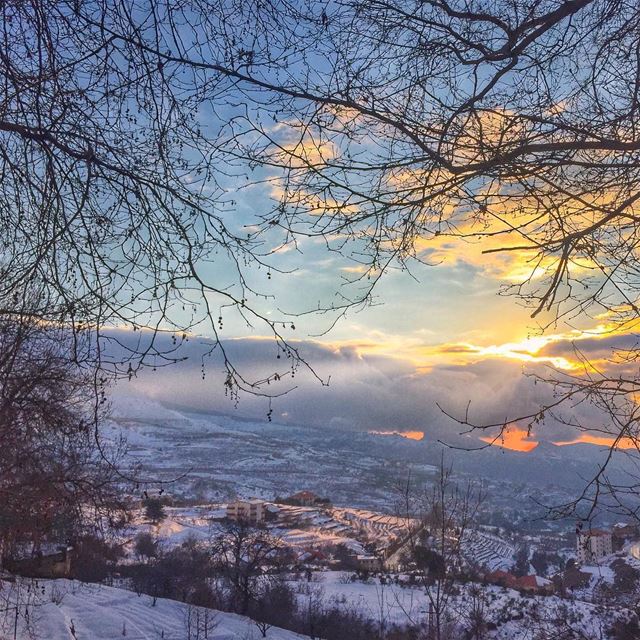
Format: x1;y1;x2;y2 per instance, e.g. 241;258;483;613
215;0;640;517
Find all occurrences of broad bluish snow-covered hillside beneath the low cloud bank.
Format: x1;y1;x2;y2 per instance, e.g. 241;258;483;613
104;395;577;524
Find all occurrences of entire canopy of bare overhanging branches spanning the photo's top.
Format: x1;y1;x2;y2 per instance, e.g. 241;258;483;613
0;0;640;520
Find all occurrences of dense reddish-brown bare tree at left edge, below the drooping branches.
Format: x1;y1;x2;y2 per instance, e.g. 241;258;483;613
0;316;125;556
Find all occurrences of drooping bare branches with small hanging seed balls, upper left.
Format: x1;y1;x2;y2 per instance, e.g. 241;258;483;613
0;0;330;394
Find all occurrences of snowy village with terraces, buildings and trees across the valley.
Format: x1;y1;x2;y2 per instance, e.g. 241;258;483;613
2;490;640;638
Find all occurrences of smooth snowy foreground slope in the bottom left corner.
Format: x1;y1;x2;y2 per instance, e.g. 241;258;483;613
0;580;305;640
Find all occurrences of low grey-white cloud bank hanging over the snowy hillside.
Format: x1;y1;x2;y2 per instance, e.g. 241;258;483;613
106;328;624;444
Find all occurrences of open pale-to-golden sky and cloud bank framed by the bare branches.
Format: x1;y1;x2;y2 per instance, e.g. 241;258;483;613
117;188;629;451
